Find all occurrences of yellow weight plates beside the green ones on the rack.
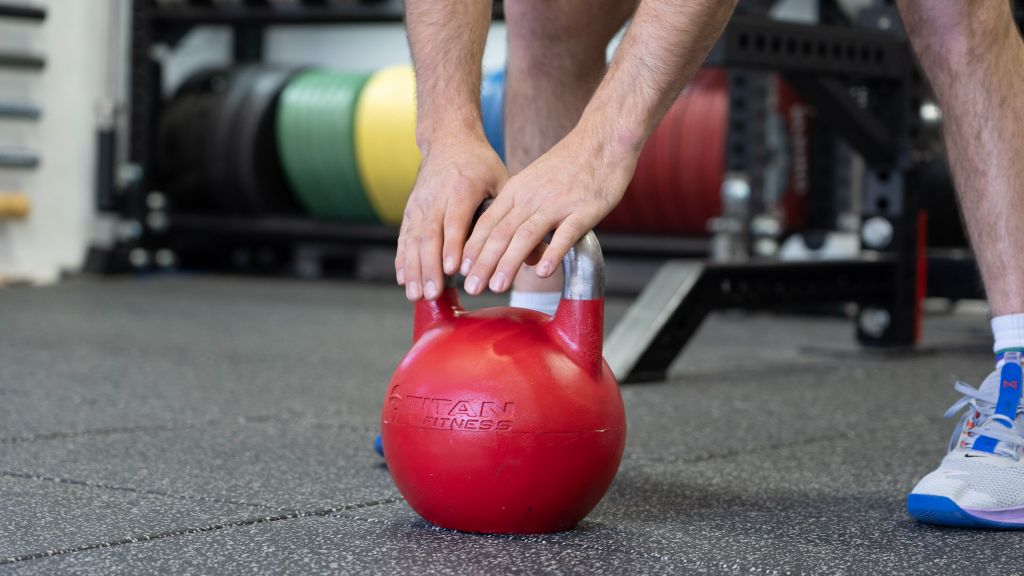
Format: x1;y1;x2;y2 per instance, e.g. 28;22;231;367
355;67;420;224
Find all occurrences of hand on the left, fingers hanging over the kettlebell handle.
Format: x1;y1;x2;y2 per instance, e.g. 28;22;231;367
394;132;508;301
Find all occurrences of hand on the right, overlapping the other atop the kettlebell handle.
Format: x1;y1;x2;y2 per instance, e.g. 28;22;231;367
461;128;639;294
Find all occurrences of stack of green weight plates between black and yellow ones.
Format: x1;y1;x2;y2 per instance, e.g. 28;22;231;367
276;71;376;221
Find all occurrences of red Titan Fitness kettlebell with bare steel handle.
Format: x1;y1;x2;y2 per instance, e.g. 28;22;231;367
381;233;626;534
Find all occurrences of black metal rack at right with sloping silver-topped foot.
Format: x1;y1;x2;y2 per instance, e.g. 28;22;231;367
605;1;927;381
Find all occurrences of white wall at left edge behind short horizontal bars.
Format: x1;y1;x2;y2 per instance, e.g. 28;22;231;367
0;0;114;284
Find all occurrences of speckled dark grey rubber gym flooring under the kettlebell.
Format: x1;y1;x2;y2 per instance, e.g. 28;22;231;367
0;277;1024;575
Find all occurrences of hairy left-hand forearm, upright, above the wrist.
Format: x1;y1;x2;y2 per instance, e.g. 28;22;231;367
406;0;492;153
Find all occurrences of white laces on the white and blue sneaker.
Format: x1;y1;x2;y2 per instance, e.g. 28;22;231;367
945;380;1024;460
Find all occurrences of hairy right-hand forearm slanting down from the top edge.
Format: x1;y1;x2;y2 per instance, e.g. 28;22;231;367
579;0;736;154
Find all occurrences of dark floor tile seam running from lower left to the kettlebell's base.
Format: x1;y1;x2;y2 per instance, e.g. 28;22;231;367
0;497;400;566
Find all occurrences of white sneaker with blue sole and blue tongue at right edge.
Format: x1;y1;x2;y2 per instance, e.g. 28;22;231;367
906;353;1024;528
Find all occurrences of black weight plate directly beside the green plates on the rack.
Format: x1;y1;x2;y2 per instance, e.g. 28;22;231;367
233;69;298;213
